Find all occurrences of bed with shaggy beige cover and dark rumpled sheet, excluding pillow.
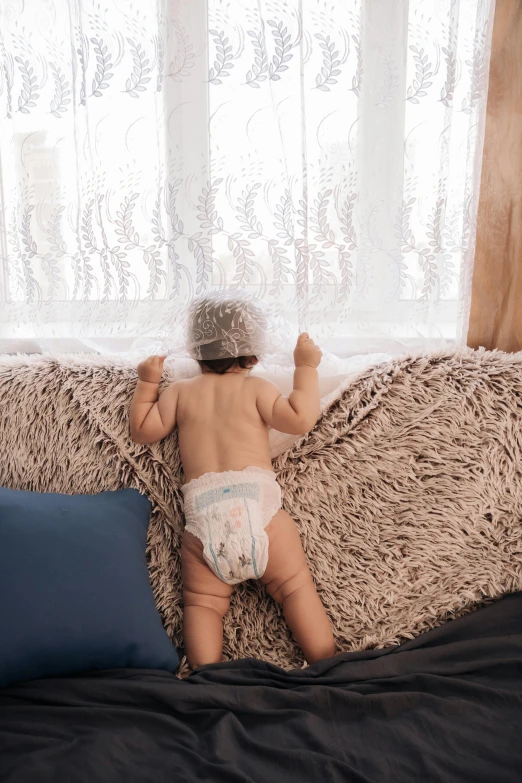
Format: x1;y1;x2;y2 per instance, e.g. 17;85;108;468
0;351;522;783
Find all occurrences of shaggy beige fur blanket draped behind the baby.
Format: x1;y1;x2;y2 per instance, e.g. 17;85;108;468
0;351;522;667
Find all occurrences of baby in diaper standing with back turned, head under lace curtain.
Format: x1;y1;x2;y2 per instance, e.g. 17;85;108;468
130;297;335;668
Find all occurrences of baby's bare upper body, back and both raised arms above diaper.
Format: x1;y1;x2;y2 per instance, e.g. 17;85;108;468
130;333;321;482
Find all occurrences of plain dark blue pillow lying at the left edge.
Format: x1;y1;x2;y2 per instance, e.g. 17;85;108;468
0;487;179;686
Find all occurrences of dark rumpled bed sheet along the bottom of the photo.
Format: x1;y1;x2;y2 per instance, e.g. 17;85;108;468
0;593;522;783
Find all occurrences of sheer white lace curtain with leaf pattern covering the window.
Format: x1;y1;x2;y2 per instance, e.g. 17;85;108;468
0;0;494;356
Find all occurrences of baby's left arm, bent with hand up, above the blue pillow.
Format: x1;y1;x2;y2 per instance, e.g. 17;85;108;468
130;356;179;444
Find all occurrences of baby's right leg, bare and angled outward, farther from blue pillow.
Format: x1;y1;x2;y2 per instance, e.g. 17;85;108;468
261;510;335;663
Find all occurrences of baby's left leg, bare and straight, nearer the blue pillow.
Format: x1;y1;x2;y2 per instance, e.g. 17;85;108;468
181;532;232;669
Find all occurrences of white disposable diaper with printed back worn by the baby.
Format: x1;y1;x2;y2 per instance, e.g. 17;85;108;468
182;467;281;585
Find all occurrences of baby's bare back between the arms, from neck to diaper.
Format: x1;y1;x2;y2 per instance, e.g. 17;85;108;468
177;372;272;481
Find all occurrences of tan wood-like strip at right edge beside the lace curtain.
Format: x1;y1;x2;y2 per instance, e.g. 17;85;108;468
468;0;522;351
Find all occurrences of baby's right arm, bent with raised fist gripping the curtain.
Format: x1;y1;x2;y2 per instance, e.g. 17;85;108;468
257;332;322;435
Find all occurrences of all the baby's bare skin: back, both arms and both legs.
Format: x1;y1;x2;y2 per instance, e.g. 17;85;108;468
130;333;334;668
